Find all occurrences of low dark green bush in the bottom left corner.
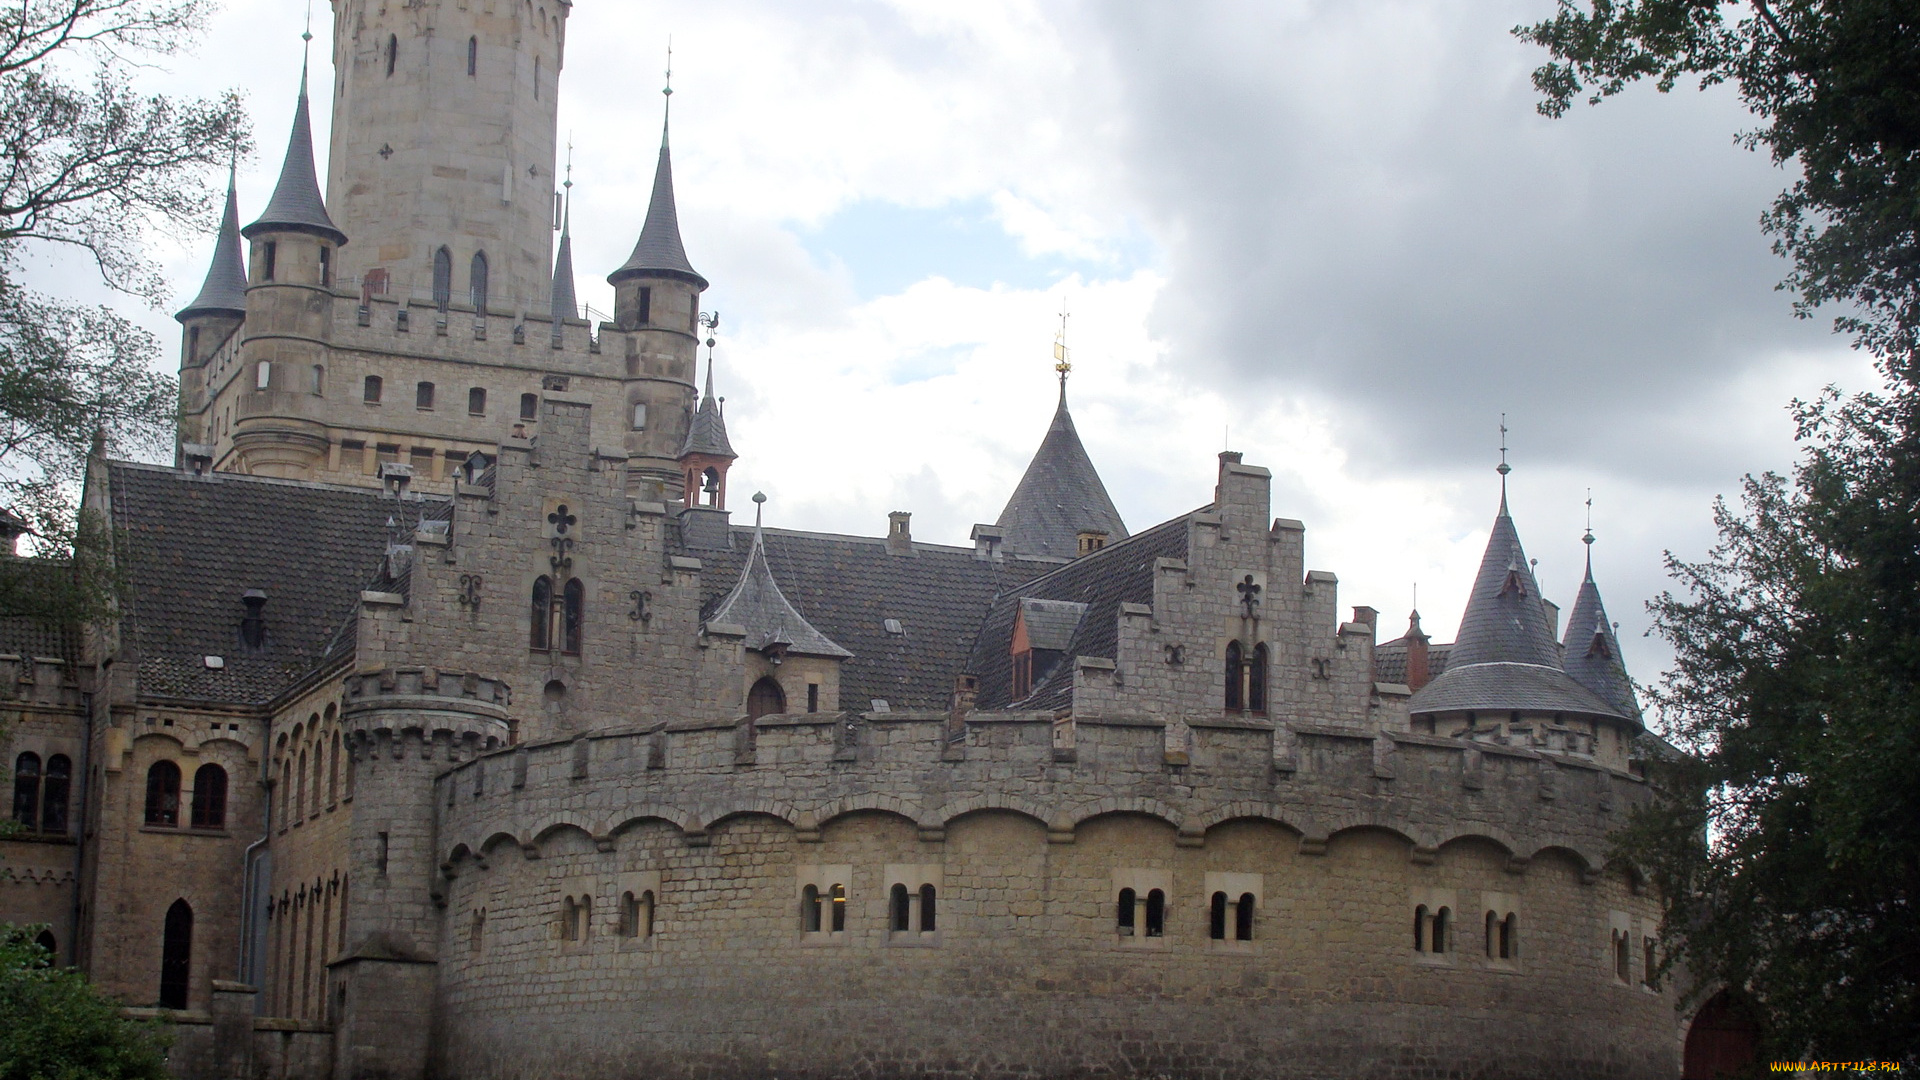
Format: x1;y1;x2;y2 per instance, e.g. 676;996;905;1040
0;924;169;1080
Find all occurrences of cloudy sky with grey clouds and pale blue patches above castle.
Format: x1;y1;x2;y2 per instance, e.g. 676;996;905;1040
40;0;1868;707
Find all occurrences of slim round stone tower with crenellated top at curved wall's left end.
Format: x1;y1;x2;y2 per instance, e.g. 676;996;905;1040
330;669;509;1076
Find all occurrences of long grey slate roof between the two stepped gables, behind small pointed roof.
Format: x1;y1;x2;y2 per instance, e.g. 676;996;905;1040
676;527;1029;711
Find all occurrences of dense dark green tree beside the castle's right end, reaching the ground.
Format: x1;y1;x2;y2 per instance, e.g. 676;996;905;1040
1620;384;1920;1065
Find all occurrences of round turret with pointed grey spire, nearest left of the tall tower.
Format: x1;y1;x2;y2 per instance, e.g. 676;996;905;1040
230;65;348;477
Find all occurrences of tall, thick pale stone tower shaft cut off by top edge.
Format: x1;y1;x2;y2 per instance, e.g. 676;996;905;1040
326;0;572;313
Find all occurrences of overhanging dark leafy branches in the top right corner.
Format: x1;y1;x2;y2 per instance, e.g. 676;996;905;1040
1513;0;1920;382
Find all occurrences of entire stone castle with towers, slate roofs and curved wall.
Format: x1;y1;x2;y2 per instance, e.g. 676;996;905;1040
0;0;1682;1080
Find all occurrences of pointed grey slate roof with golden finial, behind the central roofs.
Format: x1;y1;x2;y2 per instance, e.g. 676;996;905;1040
998;386;1127;557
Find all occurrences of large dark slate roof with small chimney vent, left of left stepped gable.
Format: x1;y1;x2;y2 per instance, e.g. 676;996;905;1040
108;461;445;705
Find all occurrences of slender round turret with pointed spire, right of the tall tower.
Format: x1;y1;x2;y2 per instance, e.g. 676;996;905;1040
607;90;707;498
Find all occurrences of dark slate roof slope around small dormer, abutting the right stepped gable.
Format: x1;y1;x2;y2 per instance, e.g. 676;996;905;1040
968;515;1192;709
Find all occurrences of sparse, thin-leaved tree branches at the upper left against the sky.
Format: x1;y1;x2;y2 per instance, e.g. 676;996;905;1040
0;0;250;621
